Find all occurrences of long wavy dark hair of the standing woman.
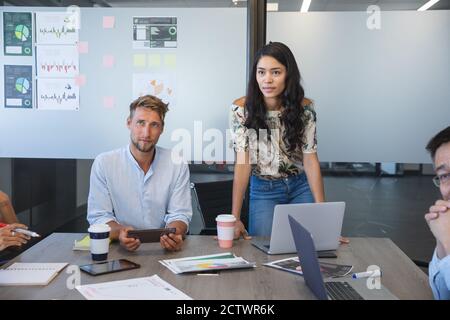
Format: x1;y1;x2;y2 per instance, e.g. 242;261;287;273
245;42;305;152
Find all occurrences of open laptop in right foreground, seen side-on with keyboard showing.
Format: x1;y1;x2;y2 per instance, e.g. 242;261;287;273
289;215;397;300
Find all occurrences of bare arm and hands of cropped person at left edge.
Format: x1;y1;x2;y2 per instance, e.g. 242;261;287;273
0;191;30;251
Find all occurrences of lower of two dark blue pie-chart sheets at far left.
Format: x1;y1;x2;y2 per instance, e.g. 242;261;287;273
4;65;33;108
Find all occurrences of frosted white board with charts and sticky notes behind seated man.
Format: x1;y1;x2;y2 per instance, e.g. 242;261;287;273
0;7;246;161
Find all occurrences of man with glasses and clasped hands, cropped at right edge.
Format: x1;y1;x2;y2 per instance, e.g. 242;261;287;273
425;127;450;300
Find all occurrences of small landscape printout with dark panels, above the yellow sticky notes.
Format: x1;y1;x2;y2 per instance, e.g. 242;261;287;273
133;17;177;49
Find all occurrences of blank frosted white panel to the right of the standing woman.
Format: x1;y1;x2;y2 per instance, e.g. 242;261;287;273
267;10;450;163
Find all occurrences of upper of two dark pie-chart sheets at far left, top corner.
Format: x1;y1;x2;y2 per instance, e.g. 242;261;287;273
3;12;33;56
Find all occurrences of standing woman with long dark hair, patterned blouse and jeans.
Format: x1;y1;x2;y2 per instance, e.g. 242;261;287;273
231;42;324;239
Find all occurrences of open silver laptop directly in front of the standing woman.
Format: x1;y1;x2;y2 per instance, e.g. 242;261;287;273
252;202;345;257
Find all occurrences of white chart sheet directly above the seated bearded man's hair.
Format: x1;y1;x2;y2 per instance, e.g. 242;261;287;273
133;73;176;106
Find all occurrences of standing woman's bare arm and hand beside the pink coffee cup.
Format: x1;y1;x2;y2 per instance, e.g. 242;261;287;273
231;151;252;240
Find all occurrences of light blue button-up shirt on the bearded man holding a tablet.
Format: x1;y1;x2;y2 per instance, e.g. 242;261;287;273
87;146;192;229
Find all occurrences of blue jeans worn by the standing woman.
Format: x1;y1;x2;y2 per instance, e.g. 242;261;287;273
249;173;314;237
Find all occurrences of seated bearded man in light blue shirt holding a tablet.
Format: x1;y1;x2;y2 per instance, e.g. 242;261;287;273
87;95;192;251
